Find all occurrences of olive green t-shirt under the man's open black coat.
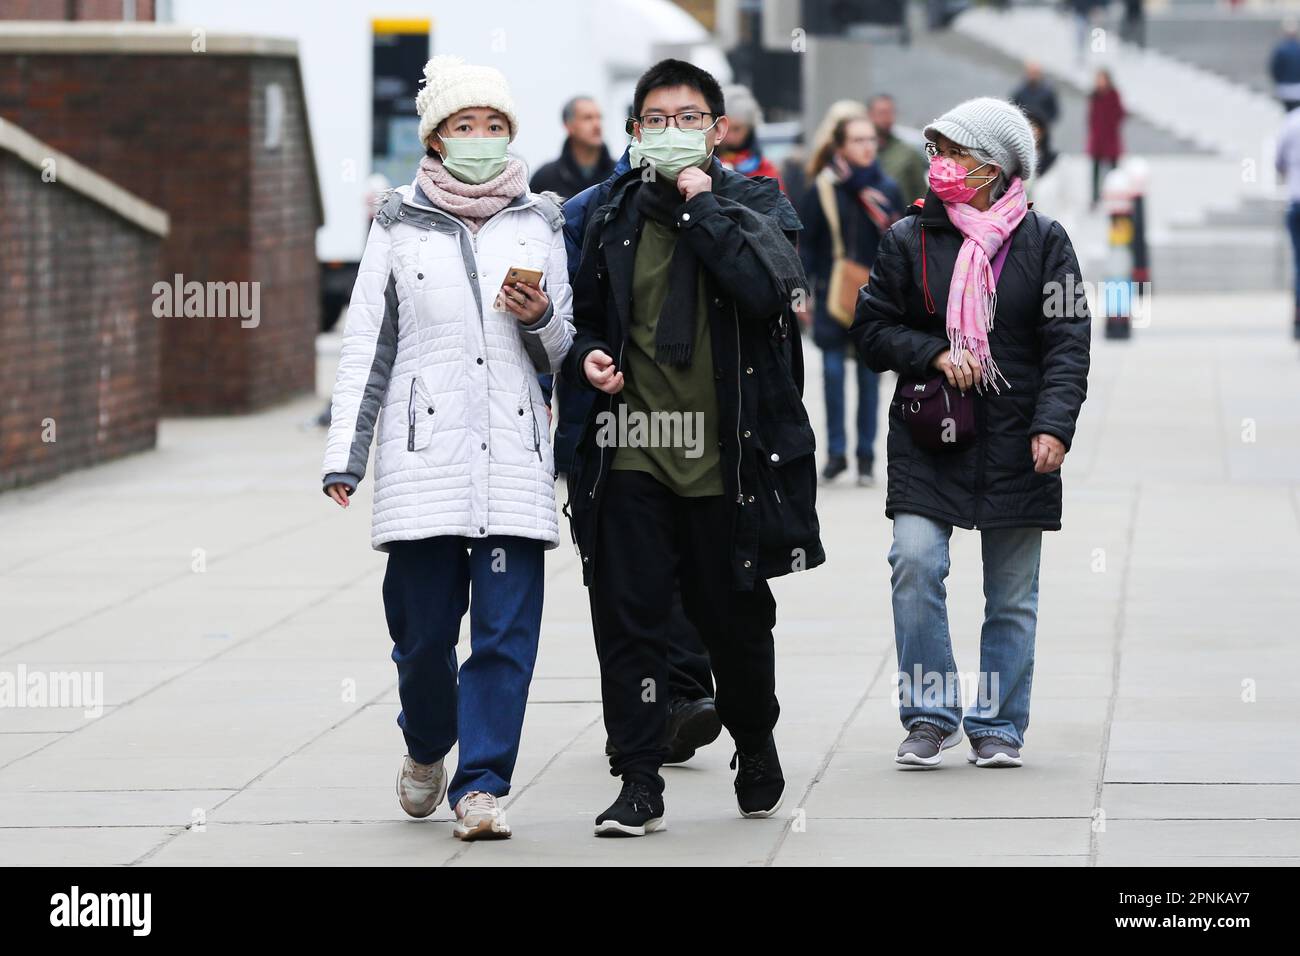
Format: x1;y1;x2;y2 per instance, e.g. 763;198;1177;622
612;219;724;498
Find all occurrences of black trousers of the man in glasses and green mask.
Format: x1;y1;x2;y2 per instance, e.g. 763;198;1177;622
589;471;780;790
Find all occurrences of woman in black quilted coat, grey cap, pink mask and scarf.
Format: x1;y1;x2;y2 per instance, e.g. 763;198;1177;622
850;98;1091;766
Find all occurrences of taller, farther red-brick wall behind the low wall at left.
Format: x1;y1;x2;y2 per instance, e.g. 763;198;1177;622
0;53;320;414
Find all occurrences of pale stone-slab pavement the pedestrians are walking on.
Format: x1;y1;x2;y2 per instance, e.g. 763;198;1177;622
0;295;1300;865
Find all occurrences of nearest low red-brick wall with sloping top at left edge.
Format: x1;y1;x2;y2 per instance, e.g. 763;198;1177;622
0;151;160;489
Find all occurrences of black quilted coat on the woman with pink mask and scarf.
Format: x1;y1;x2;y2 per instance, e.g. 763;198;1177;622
849;193;1091;531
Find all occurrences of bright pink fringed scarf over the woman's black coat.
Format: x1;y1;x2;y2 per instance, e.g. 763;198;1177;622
944;177;1028;392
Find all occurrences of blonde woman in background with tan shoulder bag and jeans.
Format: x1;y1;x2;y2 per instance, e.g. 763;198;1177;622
800;113;904;486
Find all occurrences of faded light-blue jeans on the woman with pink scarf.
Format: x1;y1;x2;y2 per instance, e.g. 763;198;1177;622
889;514;1043;747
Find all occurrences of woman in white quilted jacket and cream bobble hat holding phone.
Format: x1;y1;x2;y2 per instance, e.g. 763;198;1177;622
322;56;573;839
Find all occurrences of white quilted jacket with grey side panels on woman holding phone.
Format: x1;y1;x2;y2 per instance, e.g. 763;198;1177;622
322;186;573;551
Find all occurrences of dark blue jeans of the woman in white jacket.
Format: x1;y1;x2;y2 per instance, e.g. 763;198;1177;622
384;535;545;806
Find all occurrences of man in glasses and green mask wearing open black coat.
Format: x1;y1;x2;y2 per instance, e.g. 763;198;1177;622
564;60;824;835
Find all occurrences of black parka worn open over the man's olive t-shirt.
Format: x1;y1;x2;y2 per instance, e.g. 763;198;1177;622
563;161;826;591
